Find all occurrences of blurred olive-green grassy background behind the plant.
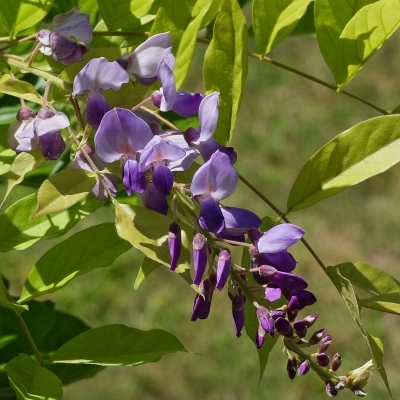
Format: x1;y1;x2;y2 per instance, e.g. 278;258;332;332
0;4;400;400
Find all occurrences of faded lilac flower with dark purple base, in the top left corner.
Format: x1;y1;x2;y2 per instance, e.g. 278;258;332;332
38;7;93;65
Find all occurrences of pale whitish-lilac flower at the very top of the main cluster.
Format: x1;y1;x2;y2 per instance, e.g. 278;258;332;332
123;32;172;85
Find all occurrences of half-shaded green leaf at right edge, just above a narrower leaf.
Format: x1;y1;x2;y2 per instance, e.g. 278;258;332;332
336;262;400;295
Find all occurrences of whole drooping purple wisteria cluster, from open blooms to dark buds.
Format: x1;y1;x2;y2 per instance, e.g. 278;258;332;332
0;2;394;397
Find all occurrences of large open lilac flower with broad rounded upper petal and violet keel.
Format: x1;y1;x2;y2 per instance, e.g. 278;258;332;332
94;108;153;195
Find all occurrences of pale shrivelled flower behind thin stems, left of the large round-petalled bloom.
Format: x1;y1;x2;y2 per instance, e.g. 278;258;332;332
68;145;118;201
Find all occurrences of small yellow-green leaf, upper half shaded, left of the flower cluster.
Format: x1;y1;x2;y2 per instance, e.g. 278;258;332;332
32;168;96;218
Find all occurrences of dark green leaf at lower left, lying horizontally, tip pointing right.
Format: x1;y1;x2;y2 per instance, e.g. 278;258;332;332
50;325;187;366
